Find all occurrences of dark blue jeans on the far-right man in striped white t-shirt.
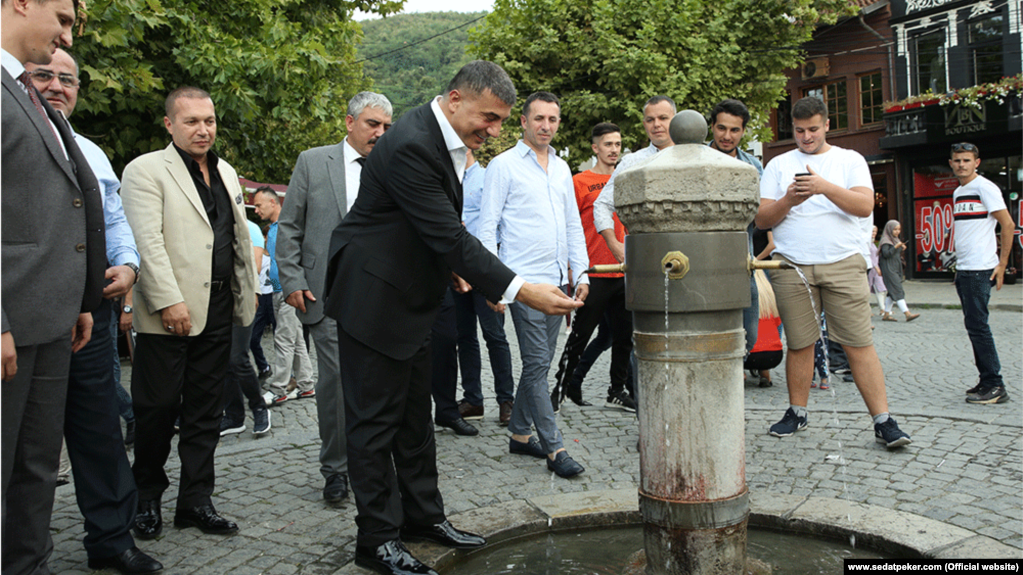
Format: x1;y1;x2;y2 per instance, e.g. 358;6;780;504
955;269;1005;388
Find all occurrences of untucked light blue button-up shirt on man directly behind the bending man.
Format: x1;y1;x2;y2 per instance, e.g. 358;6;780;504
478;140;589;285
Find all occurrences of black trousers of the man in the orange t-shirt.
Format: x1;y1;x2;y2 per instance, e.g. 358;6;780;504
554;277;635;395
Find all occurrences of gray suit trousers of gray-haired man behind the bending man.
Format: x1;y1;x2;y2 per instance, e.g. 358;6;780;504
306;317;348;478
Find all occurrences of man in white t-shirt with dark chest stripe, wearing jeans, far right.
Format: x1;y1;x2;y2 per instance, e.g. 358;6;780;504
948;142;1016;404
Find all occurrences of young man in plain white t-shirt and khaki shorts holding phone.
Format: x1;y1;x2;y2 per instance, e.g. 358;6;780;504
756;97;910;448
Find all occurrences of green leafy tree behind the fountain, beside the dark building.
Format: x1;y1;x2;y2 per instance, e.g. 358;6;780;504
470;0;853;166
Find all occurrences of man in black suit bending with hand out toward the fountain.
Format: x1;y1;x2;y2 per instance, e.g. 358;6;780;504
325;60;582;574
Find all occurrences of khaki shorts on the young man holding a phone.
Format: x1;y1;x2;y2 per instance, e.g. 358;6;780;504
770;254;874;350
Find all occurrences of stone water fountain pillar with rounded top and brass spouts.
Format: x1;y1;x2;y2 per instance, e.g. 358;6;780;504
593;110;759;575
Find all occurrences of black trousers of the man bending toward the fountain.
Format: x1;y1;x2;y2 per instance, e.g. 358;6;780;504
338;323;444;546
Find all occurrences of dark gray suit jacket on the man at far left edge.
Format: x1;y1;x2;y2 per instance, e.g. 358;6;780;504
0;68;106;347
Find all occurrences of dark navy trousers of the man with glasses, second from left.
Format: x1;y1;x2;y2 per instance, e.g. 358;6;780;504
64;300;138;559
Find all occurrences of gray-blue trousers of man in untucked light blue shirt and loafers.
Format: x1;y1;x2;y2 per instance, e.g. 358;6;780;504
508;296;565;453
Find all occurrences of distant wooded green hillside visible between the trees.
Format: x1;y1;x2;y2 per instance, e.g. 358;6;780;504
359;12;486;119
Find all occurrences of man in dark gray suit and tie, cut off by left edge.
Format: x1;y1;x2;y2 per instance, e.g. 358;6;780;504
0;0;106;575
